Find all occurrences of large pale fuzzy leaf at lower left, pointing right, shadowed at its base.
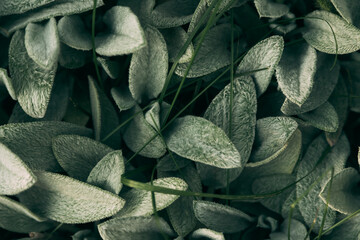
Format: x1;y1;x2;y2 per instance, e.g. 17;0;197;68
19;171;125;224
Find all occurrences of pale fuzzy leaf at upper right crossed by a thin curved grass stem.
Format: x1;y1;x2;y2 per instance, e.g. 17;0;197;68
303;11;360;54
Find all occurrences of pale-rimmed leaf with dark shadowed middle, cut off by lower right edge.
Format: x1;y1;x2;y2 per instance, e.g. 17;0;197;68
320;168;360;214
